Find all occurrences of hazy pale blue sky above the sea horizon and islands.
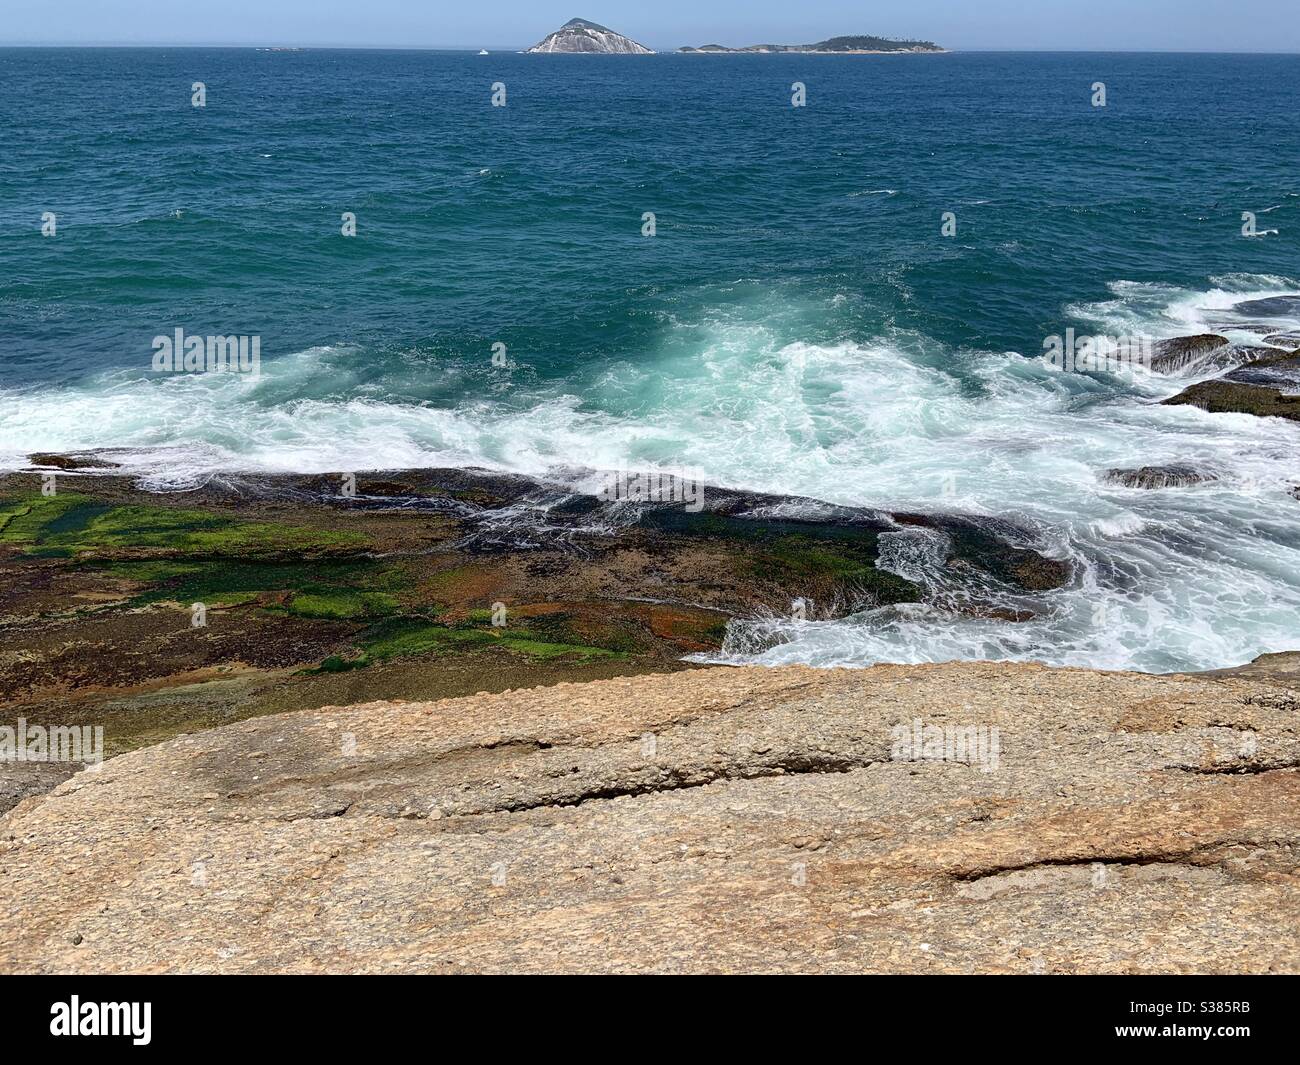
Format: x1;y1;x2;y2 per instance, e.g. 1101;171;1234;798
0;0;1300;52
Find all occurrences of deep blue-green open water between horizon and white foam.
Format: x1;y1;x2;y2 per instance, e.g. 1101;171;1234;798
0;49;1300;381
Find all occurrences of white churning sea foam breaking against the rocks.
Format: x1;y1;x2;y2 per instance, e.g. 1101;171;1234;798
0;276;1300;671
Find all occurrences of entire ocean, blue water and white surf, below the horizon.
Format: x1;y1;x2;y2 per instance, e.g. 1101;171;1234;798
0;48;1300;671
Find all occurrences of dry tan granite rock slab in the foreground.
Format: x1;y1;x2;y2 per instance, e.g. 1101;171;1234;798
0;657;1300;973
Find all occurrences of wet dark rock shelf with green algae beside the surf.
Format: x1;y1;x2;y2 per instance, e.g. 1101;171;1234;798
0;465;1071;806
